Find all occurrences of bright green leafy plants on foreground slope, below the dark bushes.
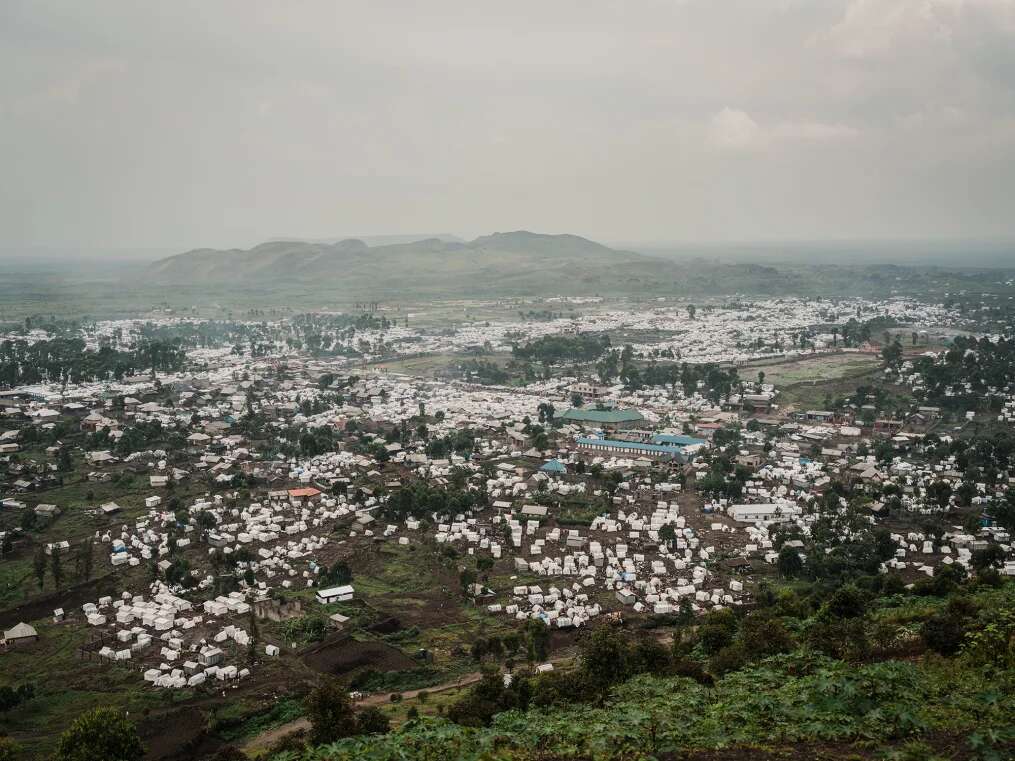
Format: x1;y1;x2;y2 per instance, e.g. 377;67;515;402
263;653;1013;761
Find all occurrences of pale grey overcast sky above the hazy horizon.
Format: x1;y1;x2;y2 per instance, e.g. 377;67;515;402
0;0;1015;250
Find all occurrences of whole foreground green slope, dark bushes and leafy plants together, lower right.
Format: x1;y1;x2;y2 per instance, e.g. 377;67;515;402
261;578;1015;761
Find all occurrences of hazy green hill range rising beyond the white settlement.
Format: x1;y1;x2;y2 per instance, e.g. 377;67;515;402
141;231;1010;301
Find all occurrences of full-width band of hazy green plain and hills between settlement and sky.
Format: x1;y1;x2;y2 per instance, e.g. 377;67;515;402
0;251;1012;332
